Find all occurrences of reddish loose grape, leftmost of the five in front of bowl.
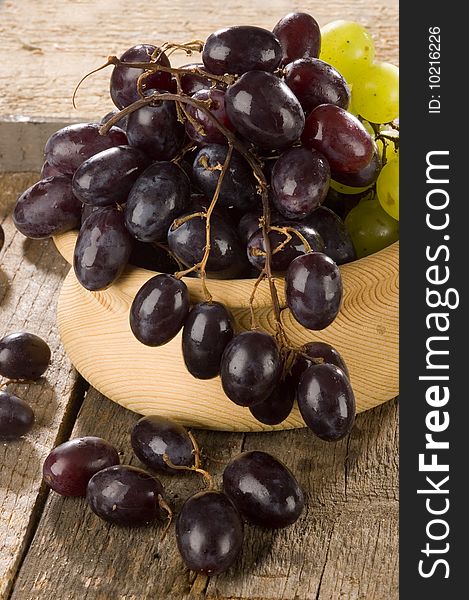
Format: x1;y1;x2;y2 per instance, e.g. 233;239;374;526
42;436;119;496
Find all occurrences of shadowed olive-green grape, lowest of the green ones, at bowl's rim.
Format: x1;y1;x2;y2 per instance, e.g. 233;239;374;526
345;197;399;258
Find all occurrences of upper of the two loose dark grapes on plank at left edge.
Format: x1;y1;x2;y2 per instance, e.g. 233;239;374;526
0;331;50;381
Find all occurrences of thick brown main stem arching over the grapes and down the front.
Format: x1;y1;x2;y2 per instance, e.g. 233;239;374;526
100;89;288;346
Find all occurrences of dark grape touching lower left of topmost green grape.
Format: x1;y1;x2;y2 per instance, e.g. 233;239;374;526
285;58;350;113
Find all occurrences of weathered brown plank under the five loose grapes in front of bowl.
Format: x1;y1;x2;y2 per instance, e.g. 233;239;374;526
12;391;398;600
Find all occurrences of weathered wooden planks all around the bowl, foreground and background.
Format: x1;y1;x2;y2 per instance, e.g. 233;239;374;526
0;0;398;600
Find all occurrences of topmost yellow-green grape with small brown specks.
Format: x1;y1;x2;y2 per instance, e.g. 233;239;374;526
319;20;375;82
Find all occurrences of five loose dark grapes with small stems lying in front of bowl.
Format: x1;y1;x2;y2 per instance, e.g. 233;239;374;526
43;415;304;575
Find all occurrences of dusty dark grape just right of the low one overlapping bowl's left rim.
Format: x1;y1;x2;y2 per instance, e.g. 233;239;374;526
125;162;191;242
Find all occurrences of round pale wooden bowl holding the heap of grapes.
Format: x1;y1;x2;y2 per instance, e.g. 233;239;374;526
54;231;399;431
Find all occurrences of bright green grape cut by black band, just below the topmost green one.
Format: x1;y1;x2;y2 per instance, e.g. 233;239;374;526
353;63;399;123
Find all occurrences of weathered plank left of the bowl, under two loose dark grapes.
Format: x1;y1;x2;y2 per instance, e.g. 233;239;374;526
0;174;86;598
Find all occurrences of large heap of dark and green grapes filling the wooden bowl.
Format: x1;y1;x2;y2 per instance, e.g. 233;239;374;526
13;13;398;441
